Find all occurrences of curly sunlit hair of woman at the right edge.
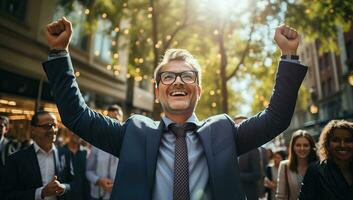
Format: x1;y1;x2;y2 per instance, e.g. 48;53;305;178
319;120;353;161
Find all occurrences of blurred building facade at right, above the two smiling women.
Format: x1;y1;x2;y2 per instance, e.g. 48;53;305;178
286;25;353;139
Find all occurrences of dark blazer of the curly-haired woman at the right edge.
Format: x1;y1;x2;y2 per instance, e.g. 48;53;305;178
299;160;353;200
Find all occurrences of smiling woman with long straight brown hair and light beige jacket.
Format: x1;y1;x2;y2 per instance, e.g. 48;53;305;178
276;130;317;200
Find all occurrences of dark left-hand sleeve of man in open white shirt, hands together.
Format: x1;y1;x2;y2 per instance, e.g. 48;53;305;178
1;156;37;200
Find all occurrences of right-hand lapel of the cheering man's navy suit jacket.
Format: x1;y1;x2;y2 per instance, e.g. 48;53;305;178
196;124;214;186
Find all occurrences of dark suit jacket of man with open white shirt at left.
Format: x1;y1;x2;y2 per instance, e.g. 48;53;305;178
1;145;73;200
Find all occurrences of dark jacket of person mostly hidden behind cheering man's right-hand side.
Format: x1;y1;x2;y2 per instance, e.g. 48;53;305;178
239;149;262;200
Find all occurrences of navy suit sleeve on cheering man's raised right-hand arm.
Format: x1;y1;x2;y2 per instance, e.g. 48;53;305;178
235;61;307;155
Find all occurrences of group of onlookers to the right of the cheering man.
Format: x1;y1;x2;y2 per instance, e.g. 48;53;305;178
234;116;353;200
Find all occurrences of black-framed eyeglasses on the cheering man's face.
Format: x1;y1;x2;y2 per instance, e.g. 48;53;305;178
157;70;197;85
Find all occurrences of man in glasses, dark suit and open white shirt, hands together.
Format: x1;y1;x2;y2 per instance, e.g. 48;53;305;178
1;111;73;200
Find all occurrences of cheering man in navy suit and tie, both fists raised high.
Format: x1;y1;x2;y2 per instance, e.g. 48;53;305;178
43;18;307;200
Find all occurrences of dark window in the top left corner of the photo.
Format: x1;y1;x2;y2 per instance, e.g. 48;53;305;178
0;0;27;21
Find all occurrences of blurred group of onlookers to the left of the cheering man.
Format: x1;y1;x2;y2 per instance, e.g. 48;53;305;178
0;105;123;200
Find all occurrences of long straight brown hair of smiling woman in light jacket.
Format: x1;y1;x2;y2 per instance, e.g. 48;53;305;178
288;130;317;172
